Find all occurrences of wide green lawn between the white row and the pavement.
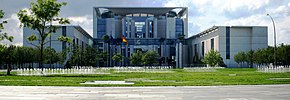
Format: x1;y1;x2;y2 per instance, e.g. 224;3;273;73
0;68;290;86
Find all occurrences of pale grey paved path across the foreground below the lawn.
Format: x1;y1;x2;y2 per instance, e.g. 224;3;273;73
0;85;290;100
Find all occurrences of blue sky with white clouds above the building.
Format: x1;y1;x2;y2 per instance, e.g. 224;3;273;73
0;0;290;45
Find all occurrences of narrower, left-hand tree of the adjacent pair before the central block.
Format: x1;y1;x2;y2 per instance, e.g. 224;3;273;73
130;50;143;66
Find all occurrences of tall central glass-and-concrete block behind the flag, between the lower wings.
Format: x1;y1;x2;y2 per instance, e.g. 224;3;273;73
93;7;188;66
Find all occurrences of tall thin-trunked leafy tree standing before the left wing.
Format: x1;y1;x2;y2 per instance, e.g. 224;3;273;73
17;0;69;70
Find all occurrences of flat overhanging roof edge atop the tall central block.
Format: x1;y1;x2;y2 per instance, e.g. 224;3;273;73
94;7;187;16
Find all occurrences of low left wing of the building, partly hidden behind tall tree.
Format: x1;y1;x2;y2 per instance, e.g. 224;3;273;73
23;25;93;52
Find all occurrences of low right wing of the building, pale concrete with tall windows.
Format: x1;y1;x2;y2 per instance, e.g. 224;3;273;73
186;26;268;67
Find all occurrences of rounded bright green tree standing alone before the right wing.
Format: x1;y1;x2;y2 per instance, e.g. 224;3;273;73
203;49;222;67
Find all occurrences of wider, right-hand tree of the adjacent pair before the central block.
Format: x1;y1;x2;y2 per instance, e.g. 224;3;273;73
142;50;160;65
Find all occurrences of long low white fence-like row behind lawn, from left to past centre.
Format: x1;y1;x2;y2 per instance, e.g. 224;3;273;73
17;66;173;75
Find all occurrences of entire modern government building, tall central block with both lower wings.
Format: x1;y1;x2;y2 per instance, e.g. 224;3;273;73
23;7;268;68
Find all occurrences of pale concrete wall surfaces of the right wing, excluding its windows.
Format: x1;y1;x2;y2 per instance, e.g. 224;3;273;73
187;26;268;67
